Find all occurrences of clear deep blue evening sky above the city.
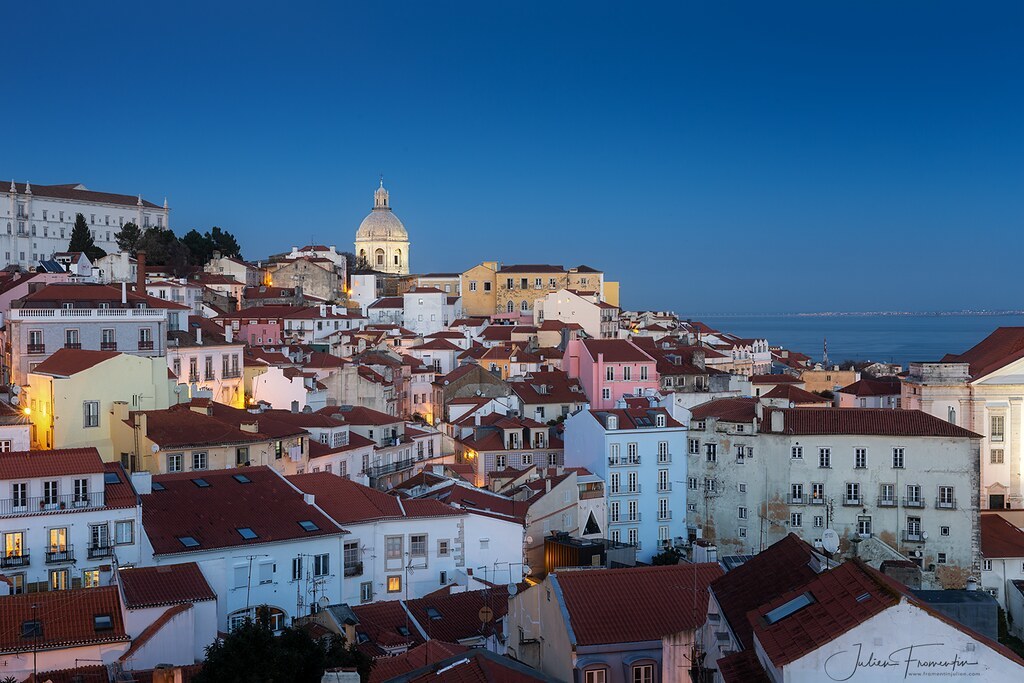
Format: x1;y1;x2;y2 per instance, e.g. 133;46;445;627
0;1;1024;312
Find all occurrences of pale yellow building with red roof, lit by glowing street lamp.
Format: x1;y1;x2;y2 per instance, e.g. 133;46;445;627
25;348;176;465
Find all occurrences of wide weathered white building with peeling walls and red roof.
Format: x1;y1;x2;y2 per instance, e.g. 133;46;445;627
687;398;978;588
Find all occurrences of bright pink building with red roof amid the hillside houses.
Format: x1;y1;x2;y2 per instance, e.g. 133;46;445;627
562;339;658;410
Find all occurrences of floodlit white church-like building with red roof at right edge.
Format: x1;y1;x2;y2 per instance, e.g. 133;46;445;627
901;328;1024;510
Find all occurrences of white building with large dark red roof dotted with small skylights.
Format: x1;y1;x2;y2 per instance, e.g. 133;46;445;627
133;467;345;631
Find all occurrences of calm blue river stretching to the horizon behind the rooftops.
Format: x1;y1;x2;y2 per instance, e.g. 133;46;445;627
693;315;1024;368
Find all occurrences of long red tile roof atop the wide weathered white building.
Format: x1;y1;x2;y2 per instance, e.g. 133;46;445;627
762;408;981;438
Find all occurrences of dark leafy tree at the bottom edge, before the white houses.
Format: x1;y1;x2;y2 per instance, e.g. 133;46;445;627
194;609;373;683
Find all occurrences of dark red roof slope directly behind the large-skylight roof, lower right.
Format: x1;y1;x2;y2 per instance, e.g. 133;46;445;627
711;533;817;648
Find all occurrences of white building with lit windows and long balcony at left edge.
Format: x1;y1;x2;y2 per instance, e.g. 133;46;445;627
0;449;142;593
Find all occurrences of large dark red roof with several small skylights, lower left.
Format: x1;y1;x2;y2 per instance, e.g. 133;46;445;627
142;467;343;555
